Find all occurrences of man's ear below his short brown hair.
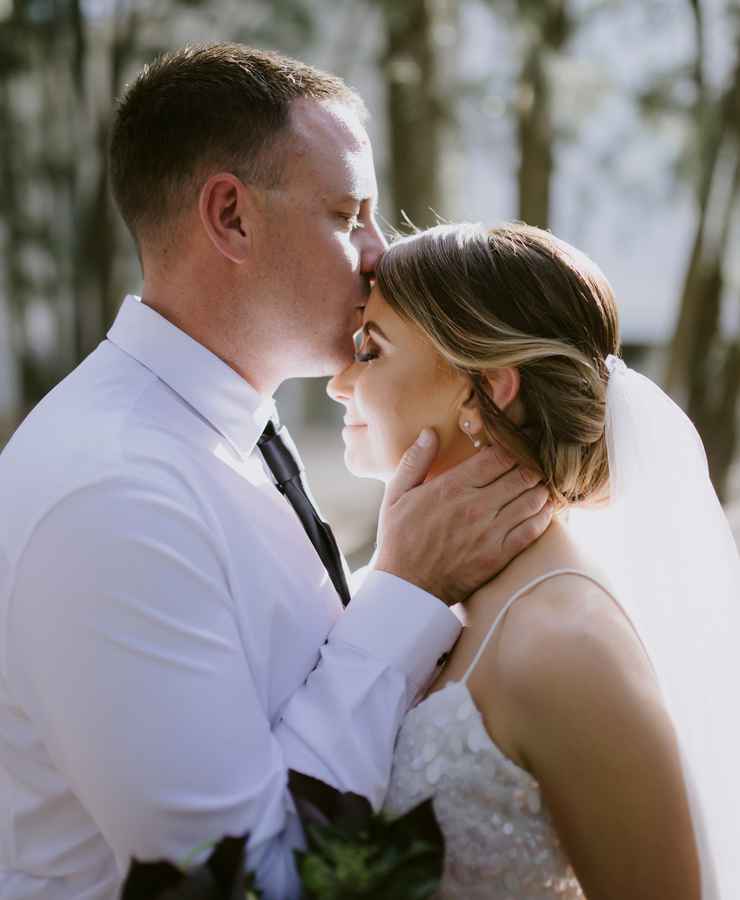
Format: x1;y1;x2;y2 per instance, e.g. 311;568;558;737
198;172;252;265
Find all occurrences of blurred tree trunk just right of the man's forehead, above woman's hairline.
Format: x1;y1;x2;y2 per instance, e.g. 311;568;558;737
380;0;457;227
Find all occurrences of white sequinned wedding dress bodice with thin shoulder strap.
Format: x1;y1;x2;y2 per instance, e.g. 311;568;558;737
384;569;610;900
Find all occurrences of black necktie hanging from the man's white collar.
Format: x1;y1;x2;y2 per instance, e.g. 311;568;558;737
257;422;350;606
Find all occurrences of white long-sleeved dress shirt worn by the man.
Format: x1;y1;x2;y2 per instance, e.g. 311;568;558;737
0;296;460;900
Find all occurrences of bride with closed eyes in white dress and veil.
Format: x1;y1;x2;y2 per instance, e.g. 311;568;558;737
329;225;740;900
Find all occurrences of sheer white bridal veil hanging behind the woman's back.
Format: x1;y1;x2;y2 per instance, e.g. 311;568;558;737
568;356;740;900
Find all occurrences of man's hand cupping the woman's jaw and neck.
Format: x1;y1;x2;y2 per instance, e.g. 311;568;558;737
375;429;552;606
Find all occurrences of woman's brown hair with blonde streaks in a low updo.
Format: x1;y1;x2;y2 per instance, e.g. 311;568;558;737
376;224;619;506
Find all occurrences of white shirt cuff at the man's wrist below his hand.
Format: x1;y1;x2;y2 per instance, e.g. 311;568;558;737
328;570;462;700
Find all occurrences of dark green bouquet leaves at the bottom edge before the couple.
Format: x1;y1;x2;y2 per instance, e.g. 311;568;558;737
121;769;444;900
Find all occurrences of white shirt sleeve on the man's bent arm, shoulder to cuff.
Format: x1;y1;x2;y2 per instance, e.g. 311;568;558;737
8;483;459;900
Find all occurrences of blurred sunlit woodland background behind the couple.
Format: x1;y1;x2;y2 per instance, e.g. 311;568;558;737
0;0;740;565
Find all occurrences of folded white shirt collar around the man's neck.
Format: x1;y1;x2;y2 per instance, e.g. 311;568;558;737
107;294;277;456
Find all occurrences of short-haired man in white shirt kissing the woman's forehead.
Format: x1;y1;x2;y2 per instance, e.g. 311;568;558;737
0;45;549;900
